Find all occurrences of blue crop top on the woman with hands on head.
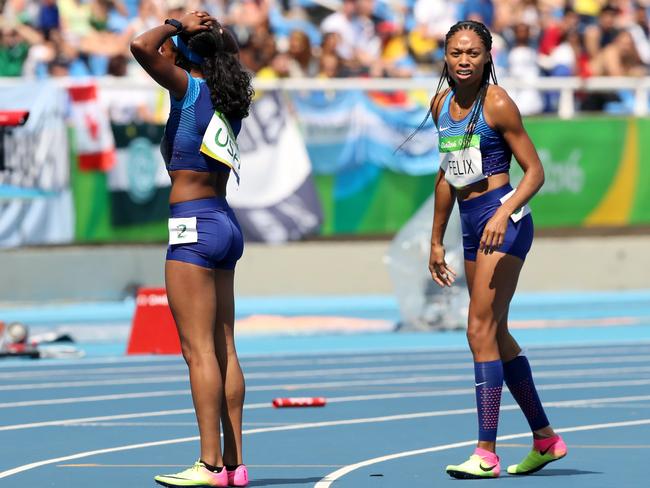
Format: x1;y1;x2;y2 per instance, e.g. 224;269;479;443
160;73;241;172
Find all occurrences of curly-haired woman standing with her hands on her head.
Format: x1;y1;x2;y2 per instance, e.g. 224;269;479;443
131;12;253;486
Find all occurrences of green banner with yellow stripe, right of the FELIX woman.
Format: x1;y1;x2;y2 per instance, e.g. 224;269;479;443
511;117;650;228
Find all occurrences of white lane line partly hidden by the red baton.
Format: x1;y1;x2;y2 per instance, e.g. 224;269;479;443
5;395;650;432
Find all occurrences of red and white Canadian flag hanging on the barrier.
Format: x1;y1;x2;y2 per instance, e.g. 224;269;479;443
68;84;115;171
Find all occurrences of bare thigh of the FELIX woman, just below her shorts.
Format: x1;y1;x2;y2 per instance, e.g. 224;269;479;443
469;252;523;322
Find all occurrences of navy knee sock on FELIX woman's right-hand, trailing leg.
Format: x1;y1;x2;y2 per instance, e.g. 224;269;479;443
503;356;549;432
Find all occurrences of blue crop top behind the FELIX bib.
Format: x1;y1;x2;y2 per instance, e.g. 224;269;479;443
438;90;512;183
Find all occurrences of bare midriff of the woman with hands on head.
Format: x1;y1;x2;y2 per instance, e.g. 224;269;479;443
169;169;230;204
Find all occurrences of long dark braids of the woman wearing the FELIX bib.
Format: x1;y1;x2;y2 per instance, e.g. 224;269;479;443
400;20;498;149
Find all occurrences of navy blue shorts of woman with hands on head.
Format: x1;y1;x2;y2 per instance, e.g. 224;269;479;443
167;198;244;269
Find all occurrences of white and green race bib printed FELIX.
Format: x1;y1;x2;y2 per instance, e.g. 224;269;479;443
438;134;485;188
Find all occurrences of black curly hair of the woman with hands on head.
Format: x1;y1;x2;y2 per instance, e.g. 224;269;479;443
176;23;255;119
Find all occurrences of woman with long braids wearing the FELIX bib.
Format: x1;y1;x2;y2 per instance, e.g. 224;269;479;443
422;21;567;479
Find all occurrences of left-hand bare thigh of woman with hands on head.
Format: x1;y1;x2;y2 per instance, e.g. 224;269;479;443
165;260;217;348
